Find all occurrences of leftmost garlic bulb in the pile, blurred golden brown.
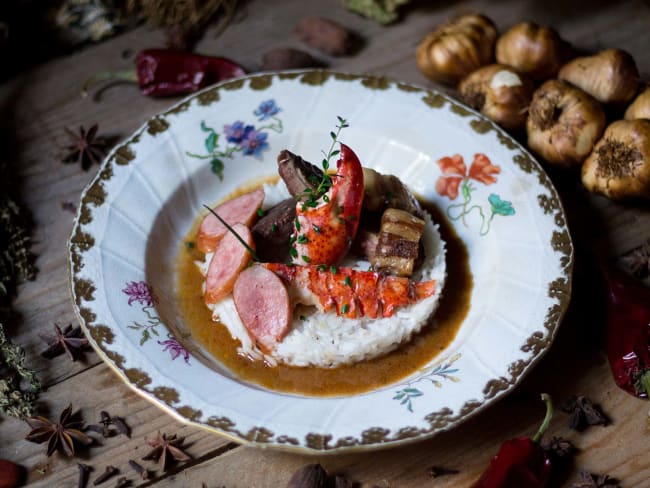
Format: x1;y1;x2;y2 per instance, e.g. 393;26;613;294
416;14;497;85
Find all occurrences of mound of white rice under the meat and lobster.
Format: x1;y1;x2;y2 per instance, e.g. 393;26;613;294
197;181;446;368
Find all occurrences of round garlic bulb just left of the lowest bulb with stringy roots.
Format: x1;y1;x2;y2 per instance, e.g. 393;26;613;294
526;80;605;168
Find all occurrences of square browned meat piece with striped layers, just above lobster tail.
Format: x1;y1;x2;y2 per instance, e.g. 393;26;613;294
370;208;424;276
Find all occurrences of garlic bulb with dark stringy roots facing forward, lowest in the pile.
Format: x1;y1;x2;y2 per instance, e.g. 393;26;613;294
582;119;650;200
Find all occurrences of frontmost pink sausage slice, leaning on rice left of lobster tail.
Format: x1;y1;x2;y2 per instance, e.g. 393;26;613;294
232;266;292;352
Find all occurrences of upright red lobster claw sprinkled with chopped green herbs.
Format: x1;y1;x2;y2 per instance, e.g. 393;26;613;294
292;144;363;265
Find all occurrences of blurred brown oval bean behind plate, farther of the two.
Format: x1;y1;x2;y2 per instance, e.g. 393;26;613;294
293;17;355;56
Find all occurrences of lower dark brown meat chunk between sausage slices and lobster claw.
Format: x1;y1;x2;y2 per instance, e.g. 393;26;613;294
252;198;296;263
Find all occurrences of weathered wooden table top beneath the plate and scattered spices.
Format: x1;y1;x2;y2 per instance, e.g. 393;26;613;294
0;0;650;488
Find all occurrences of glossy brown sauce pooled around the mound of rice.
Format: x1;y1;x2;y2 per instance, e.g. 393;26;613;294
177;199;473;396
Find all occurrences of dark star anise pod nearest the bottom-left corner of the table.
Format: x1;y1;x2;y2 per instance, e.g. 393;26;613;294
25;405;93;456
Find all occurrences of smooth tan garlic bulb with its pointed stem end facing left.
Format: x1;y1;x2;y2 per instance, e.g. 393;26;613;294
558;49;639;104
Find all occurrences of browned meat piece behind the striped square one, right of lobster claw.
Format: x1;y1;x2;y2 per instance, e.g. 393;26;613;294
363;168;422;217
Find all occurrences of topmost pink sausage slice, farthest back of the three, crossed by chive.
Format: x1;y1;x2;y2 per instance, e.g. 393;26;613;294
196;189;264;253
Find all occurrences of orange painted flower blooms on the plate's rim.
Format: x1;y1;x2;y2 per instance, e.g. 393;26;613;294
436;153;501;200
